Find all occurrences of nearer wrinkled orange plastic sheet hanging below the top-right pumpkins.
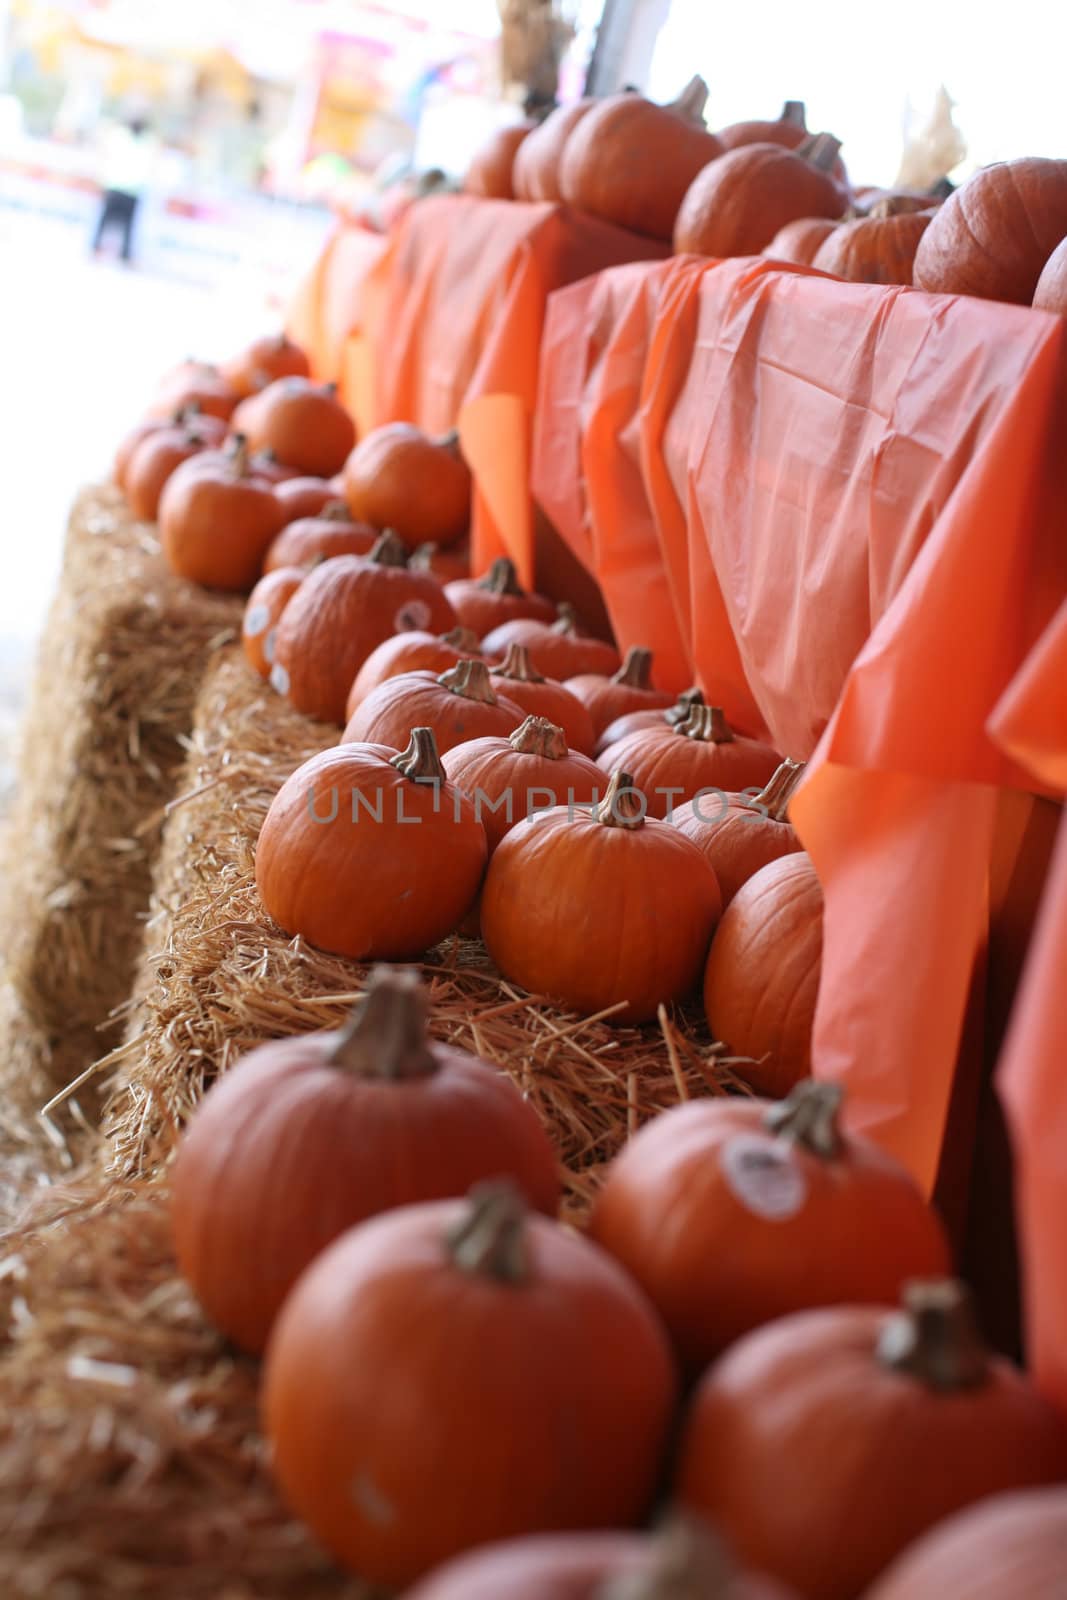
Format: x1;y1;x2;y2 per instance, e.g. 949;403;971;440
534;259;1067;1190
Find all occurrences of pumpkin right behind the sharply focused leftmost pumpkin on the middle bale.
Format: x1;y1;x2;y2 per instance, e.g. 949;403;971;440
341;661;523;755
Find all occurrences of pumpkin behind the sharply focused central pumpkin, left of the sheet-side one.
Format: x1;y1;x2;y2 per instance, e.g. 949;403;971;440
597;706;781;818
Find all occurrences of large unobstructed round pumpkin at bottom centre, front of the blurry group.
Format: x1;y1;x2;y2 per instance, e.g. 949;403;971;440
264;1186;677;1587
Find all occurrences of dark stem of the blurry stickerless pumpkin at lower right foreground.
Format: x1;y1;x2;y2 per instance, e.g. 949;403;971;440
875;1278;989;1394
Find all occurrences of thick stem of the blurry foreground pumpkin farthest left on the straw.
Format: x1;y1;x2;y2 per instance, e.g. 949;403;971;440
330;965;437;1083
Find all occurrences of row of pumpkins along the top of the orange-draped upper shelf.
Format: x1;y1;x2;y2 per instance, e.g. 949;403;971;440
466;78;1067;315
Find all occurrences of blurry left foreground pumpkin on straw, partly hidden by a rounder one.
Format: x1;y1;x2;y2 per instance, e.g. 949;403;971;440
171;966;560;1352
